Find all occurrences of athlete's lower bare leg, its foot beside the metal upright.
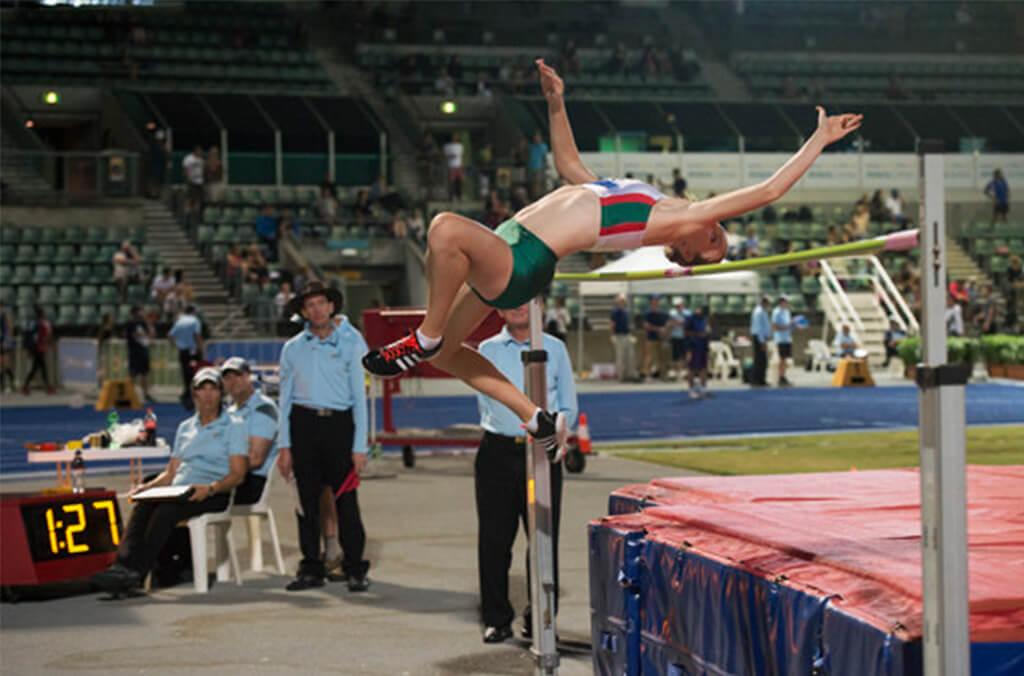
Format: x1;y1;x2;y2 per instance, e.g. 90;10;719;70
432;285;537;422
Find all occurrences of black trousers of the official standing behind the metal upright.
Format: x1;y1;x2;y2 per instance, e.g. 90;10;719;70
474;432;562;627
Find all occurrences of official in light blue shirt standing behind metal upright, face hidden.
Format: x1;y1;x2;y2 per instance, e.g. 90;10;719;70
473;305;579;643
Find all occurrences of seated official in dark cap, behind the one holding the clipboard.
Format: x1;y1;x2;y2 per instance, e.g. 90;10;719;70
220;356;279;505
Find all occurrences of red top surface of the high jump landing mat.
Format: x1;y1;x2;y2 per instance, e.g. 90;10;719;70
598;466;1024;641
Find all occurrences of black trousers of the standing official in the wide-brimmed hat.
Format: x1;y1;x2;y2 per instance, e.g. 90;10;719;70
289;406;370;577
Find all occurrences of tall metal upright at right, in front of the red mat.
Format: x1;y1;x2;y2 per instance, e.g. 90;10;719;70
918;141;971;676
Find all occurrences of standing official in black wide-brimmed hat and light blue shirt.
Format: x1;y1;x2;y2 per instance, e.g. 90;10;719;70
278;281;370;592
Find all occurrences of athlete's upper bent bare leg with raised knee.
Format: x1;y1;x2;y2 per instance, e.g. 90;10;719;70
420;211;512;338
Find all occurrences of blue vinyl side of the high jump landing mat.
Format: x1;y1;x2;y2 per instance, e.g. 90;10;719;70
590;523;920;676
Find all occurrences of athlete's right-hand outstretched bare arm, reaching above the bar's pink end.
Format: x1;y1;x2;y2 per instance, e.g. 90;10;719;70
687;105;864;222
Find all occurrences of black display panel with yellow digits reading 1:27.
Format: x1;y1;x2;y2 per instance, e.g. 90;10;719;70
22;498;121;561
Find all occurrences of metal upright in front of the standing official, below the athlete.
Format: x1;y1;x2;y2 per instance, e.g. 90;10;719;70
522;298;558;676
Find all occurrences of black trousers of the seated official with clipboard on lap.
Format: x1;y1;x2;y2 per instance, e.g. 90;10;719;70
118;494;228;576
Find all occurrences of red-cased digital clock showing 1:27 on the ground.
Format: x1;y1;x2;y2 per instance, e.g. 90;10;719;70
0;490;122;585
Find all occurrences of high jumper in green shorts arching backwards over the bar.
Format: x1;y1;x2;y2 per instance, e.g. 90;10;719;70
362;59;863;460
